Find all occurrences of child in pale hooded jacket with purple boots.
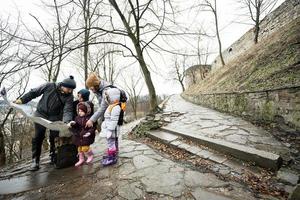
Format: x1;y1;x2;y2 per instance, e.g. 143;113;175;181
101;88;122;166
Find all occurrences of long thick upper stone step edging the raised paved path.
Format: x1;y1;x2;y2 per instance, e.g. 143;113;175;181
161;127;282;171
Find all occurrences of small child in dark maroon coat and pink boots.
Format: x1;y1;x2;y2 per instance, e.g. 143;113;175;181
69;102;96;167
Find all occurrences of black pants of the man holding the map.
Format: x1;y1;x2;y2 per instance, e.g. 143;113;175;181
32;123;59;162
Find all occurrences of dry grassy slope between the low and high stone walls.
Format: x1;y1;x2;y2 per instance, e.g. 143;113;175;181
185;18;300;95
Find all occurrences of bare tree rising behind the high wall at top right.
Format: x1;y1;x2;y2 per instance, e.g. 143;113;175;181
238;0;278;44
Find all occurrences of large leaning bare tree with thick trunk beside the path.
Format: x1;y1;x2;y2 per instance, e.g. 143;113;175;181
85;0;180;112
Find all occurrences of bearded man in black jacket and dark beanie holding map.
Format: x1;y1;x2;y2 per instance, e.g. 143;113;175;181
15;76;76;171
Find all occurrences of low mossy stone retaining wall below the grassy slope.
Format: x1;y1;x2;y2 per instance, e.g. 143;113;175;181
182;86;300;131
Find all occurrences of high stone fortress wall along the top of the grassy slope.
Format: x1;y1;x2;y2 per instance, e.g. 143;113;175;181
212;0;300;71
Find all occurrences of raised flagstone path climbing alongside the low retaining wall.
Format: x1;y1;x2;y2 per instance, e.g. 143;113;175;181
165;95;290;157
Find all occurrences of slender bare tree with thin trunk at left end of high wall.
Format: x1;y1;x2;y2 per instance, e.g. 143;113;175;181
201;0;225;66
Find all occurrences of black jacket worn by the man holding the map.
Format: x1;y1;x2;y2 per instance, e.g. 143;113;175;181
21;83;74;122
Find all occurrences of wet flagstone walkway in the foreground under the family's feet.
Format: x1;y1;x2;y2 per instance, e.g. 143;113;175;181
0;120;255;200
